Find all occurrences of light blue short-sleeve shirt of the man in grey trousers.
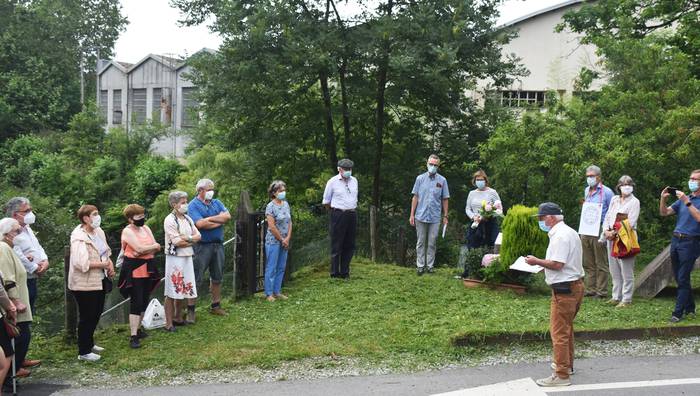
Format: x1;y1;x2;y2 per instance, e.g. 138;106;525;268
411;172;450;224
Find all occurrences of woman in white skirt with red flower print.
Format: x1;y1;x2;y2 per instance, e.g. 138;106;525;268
163;191;202;332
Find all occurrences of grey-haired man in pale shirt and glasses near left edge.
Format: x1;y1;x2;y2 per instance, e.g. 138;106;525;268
5;197;49;322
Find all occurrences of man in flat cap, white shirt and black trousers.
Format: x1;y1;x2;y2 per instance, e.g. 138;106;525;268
323;158;358;279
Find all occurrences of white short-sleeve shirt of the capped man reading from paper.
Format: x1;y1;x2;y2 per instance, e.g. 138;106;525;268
544;221;584;285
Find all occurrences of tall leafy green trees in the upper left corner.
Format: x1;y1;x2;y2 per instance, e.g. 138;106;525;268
0;0;126;141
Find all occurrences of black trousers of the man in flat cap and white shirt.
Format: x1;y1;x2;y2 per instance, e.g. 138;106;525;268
330;209;357;278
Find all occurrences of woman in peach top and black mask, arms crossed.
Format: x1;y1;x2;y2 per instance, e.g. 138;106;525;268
119;204;160;348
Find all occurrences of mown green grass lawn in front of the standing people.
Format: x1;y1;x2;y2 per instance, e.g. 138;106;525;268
30;259;700;380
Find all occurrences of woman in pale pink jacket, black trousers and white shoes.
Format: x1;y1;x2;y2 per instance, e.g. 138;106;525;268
68;205;114;362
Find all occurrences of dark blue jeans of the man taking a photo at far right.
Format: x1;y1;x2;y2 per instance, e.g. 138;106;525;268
671;237;700;318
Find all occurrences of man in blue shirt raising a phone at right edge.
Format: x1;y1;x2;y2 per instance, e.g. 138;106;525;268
659;169;700;323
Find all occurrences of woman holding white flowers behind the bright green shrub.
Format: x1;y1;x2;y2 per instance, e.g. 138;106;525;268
462;169;501;278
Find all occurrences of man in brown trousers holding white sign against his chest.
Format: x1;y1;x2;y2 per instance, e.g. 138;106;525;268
578;165;615;298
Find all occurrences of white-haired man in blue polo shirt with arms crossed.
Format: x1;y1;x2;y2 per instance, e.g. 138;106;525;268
187;179;231;323
